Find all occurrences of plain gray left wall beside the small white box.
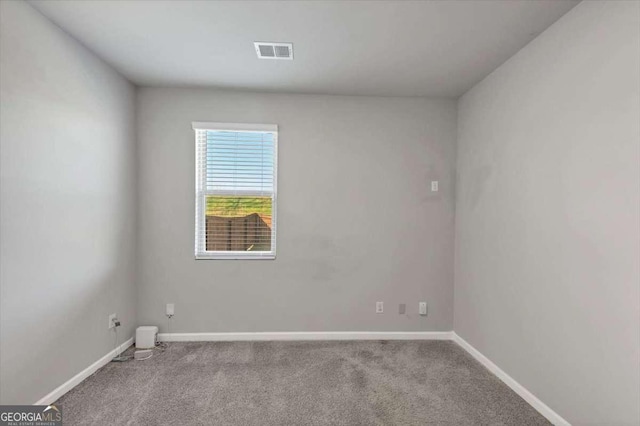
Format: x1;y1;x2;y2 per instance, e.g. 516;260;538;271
0;1;136;404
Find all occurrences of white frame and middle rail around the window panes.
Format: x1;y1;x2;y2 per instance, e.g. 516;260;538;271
192;122;278;260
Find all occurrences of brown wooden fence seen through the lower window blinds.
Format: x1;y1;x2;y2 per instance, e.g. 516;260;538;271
206;213;271;251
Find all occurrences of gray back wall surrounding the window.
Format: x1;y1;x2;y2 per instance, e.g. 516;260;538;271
138;88;456;332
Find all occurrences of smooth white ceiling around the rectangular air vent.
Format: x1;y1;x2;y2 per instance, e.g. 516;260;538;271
30;0;578;97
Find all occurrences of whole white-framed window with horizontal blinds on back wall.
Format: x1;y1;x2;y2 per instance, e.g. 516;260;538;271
193;123;278;259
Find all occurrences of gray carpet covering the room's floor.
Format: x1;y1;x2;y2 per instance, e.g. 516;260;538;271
56;341;549;425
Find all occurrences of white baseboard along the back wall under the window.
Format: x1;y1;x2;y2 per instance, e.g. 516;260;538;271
158;331;453;342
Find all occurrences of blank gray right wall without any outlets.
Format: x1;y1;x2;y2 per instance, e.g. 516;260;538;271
455;2;640;425
